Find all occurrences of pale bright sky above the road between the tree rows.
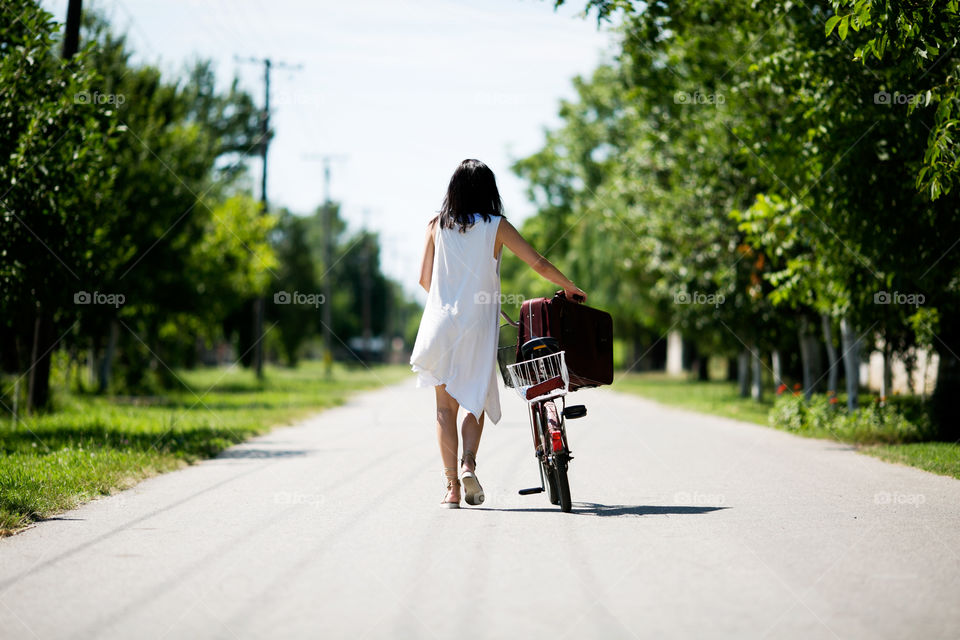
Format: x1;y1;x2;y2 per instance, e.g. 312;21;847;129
42;0;614;298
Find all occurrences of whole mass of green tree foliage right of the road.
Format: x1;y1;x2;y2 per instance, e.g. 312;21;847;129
517;0;960;425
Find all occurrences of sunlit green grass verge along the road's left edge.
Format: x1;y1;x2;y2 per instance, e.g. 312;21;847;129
0;362;409;535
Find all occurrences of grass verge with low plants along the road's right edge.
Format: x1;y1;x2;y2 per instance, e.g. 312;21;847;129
613;373;960;479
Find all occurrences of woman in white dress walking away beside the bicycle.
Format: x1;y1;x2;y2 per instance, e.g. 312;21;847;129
410;160;587;509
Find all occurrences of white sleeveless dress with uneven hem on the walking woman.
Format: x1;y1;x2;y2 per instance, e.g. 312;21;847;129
410;213;503;423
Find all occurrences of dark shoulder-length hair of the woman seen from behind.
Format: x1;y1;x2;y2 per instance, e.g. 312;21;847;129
437;159;503;233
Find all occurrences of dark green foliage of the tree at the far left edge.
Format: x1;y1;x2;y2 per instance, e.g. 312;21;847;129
0;0;113;342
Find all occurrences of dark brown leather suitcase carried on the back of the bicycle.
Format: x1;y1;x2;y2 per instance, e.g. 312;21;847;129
517;291;613;391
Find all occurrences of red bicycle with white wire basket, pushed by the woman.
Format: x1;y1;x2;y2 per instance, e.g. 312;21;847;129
497;310;587;513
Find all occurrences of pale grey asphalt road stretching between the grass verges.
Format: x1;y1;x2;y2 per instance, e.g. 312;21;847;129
0;380;960;640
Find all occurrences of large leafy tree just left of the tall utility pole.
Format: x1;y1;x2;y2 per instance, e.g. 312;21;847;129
78;14;262;390
